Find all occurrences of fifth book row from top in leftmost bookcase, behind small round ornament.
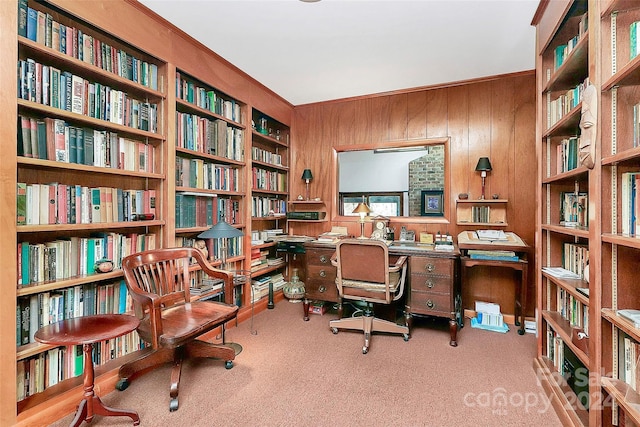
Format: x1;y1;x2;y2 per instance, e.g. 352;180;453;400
16;232;157;288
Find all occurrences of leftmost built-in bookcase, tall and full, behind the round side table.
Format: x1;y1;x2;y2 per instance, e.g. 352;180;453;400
15;1;167;414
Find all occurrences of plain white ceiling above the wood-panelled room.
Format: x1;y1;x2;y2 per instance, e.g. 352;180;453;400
140;0;538;105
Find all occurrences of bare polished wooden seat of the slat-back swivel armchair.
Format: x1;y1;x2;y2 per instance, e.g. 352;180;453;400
138;301;238;347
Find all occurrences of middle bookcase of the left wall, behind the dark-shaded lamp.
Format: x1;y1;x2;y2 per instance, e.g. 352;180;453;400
175;70;248;290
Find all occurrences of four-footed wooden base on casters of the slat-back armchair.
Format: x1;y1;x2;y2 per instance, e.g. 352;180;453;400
116;340;242;412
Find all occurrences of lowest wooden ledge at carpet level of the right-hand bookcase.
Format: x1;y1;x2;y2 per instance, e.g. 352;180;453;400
533;356;589;426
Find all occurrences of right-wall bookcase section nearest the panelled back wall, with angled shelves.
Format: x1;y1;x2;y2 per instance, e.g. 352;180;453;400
534;1;595;425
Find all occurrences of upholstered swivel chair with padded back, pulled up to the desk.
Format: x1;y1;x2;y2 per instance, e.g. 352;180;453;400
329;239;409;354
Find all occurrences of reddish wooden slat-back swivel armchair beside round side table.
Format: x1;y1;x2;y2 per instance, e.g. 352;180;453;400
116;248;238;411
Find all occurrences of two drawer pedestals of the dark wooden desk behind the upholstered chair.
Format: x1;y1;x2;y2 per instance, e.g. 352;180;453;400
299;241;462;347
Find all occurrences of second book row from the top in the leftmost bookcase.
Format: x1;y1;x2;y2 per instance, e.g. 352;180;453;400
18;58;158;132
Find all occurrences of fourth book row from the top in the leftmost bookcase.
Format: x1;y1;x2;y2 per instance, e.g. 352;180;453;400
16;182;156;225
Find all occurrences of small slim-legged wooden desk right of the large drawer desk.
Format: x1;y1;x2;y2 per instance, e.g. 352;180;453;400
458;231;530;335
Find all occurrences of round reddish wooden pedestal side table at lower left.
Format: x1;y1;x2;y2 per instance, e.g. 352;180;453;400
35;314;140;427
